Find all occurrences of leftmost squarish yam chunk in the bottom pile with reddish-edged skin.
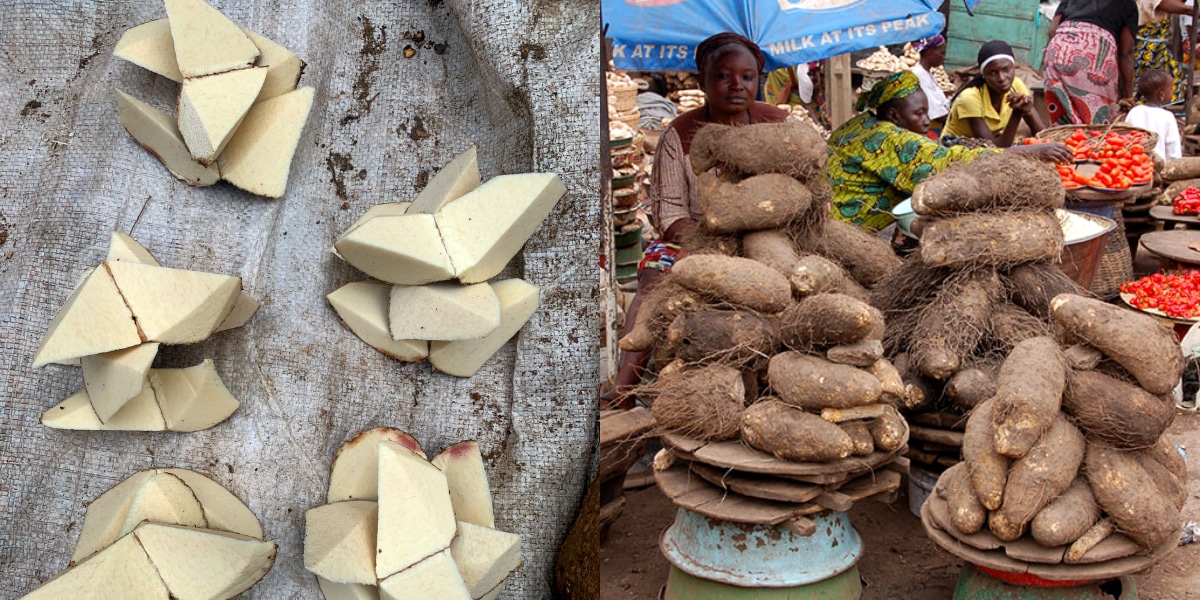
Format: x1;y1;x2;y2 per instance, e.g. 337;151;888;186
304;500;379;584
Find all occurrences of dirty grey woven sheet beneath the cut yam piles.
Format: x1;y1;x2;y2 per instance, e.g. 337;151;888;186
0;0;601;600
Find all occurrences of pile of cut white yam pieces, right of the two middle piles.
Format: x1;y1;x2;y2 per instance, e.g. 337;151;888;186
326;146;566;377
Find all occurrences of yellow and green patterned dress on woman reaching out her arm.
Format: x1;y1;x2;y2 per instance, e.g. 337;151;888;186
826;112;995;230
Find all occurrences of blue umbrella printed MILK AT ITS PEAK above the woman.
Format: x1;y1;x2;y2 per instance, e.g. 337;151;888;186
609;0;945;71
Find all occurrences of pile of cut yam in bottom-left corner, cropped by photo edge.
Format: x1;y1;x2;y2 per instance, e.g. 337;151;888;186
24;468;276;600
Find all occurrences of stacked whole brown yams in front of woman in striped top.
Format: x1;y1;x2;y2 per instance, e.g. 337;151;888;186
620;122;910;463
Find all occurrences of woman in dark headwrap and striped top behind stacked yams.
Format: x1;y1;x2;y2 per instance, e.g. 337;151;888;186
601;34;790;408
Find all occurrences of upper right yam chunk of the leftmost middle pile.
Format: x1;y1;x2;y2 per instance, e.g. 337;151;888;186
103;260;241;343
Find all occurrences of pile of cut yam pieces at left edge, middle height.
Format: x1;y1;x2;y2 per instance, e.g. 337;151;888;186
34;232;258;431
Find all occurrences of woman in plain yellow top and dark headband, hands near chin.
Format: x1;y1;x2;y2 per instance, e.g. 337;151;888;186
942;40;1045;148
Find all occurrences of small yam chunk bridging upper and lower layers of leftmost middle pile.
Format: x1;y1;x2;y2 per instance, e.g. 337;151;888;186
79;342;158;422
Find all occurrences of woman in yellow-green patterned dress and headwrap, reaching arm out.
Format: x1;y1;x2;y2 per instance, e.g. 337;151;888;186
826;71;1072;230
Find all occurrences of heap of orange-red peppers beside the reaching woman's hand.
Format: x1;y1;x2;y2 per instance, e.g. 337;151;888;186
1025;130;1154;190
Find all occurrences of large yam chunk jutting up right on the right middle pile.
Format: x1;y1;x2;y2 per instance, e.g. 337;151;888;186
434;173;566;283
